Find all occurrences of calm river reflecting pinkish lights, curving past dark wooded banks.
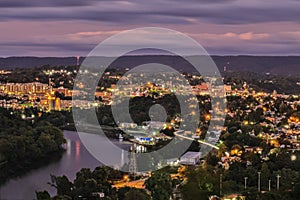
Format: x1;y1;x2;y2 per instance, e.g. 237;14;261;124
0;131;130;200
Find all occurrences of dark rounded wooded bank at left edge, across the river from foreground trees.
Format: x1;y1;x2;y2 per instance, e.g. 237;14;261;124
0;109;65;184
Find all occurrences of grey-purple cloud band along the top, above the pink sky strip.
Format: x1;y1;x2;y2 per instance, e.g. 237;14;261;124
0;0;300;24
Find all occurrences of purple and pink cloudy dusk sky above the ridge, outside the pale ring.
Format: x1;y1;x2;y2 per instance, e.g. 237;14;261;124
0;0;300;57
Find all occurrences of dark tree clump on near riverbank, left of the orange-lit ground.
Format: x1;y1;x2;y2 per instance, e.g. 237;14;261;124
36;167;124;200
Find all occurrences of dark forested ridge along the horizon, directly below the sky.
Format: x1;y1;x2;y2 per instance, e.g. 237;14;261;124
0;55;300;75
